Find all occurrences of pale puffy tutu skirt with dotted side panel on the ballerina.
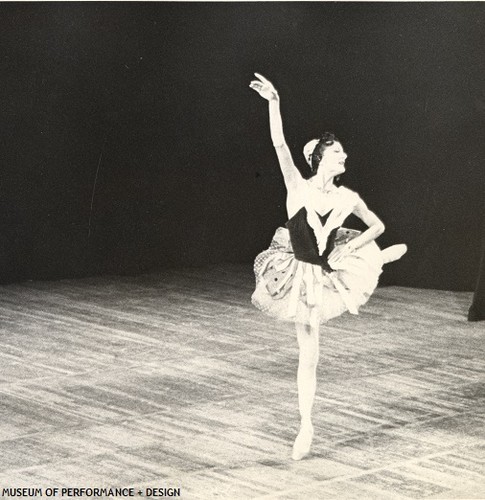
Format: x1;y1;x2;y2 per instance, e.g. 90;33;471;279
251;227;384;326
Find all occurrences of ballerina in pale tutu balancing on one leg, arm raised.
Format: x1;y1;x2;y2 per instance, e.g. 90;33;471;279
249;73;407;460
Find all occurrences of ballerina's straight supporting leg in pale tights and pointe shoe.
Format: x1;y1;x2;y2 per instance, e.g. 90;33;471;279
292;323;319;460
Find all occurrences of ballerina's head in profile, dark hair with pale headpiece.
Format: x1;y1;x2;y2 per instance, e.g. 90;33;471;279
303;132;347;178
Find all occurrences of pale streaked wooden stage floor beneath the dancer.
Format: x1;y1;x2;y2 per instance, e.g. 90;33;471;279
0;265;485;500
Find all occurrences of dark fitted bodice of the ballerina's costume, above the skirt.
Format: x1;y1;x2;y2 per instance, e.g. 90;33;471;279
286;207;338;271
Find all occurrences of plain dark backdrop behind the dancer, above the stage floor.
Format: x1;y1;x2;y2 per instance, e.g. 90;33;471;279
0;2;485;290
